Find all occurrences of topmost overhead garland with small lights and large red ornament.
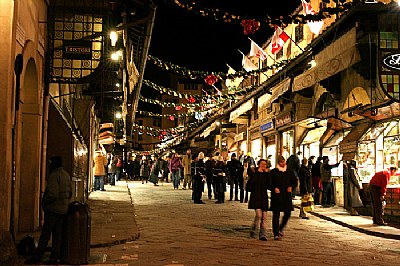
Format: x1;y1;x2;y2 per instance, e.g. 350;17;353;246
173;0;354;35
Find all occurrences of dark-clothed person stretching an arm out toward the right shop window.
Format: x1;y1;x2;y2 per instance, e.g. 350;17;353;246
321;156;342;208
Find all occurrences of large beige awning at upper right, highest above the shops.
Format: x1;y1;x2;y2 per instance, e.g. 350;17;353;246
292;28;361;92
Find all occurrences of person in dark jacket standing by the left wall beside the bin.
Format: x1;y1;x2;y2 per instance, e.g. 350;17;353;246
25;156;71;264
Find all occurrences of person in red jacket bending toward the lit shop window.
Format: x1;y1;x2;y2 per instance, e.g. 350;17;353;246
369;167;397;225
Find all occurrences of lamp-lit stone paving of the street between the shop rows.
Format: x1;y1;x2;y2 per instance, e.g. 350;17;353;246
91;181;400;266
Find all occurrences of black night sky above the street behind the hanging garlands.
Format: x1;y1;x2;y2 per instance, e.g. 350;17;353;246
141;0;301;107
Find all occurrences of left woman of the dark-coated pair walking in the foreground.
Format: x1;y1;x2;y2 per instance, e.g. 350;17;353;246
247;159;270;241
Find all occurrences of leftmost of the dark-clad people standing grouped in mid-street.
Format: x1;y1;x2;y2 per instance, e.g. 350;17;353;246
191;152;206;204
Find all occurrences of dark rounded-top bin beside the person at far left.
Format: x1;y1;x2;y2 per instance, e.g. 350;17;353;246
61;201;91;264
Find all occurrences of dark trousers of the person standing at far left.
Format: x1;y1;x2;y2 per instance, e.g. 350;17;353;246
35;211;65;260
